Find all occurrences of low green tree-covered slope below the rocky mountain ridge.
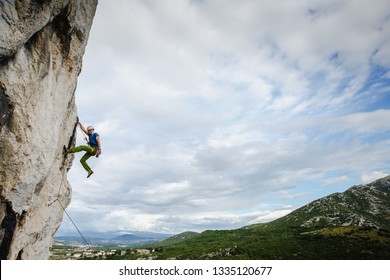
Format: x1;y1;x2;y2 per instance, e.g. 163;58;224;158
145;224;390;260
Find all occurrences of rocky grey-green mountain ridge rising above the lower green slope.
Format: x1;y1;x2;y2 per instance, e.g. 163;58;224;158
272;176;390;230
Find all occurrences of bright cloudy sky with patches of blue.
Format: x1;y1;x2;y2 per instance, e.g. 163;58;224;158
58;0;390;235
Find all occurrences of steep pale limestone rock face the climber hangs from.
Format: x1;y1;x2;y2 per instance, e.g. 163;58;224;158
0;0;97;259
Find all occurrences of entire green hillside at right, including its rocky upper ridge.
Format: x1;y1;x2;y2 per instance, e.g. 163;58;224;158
118;177;390;260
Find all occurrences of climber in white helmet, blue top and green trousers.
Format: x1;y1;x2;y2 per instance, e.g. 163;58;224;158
66;122;102;178
